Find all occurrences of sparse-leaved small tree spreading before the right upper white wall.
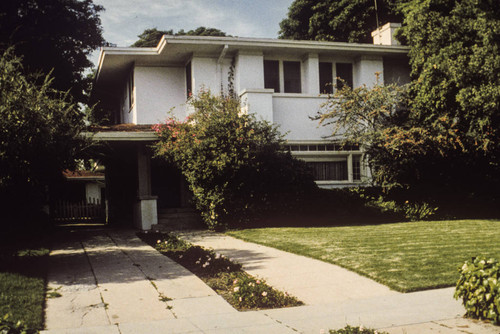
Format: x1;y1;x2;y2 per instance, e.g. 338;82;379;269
317;76;442;188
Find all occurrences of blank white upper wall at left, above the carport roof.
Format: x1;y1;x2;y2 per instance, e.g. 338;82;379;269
134;66;186;124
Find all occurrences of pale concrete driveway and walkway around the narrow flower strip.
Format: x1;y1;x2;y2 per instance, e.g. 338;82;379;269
43;230;500;334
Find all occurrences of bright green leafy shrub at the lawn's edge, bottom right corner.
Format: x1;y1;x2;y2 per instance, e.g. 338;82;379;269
455;257;500;324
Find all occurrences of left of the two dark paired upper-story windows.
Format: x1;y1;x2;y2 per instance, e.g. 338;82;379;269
264;60;302;93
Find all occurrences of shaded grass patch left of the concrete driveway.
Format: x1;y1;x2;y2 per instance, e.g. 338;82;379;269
0;241;49;329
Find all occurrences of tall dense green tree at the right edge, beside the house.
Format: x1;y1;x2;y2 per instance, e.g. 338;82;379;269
394;0;500;193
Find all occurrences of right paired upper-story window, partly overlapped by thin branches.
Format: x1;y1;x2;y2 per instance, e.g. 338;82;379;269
319;62;353;94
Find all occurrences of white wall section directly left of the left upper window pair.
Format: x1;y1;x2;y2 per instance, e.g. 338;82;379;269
234;53;264;94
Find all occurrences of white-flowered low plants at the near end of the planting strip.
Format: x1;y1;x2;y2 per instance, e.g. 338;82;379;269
233;276;302;309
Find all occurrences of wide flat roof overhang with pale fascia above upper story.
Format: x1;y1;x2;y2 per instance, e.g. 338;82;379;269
96;35;409;86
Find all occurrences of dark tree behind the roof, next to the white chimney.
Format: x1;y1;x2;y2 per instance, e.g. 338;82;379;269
279;0;405;43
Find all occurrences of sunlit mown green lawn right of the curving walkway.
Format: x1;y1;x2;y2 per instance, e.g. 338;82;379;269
227;220;500;292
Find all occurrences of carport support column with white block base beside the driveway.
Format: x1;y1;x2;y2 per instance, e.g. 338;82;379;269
134;144;158;230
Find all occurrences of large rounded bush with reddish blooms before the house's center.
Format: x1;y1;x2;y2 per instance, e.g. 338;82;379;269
155;91;315;229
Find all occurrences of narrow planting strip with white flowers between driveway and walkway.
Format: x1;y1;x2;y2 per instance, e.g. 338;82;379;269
139;233;303;311
